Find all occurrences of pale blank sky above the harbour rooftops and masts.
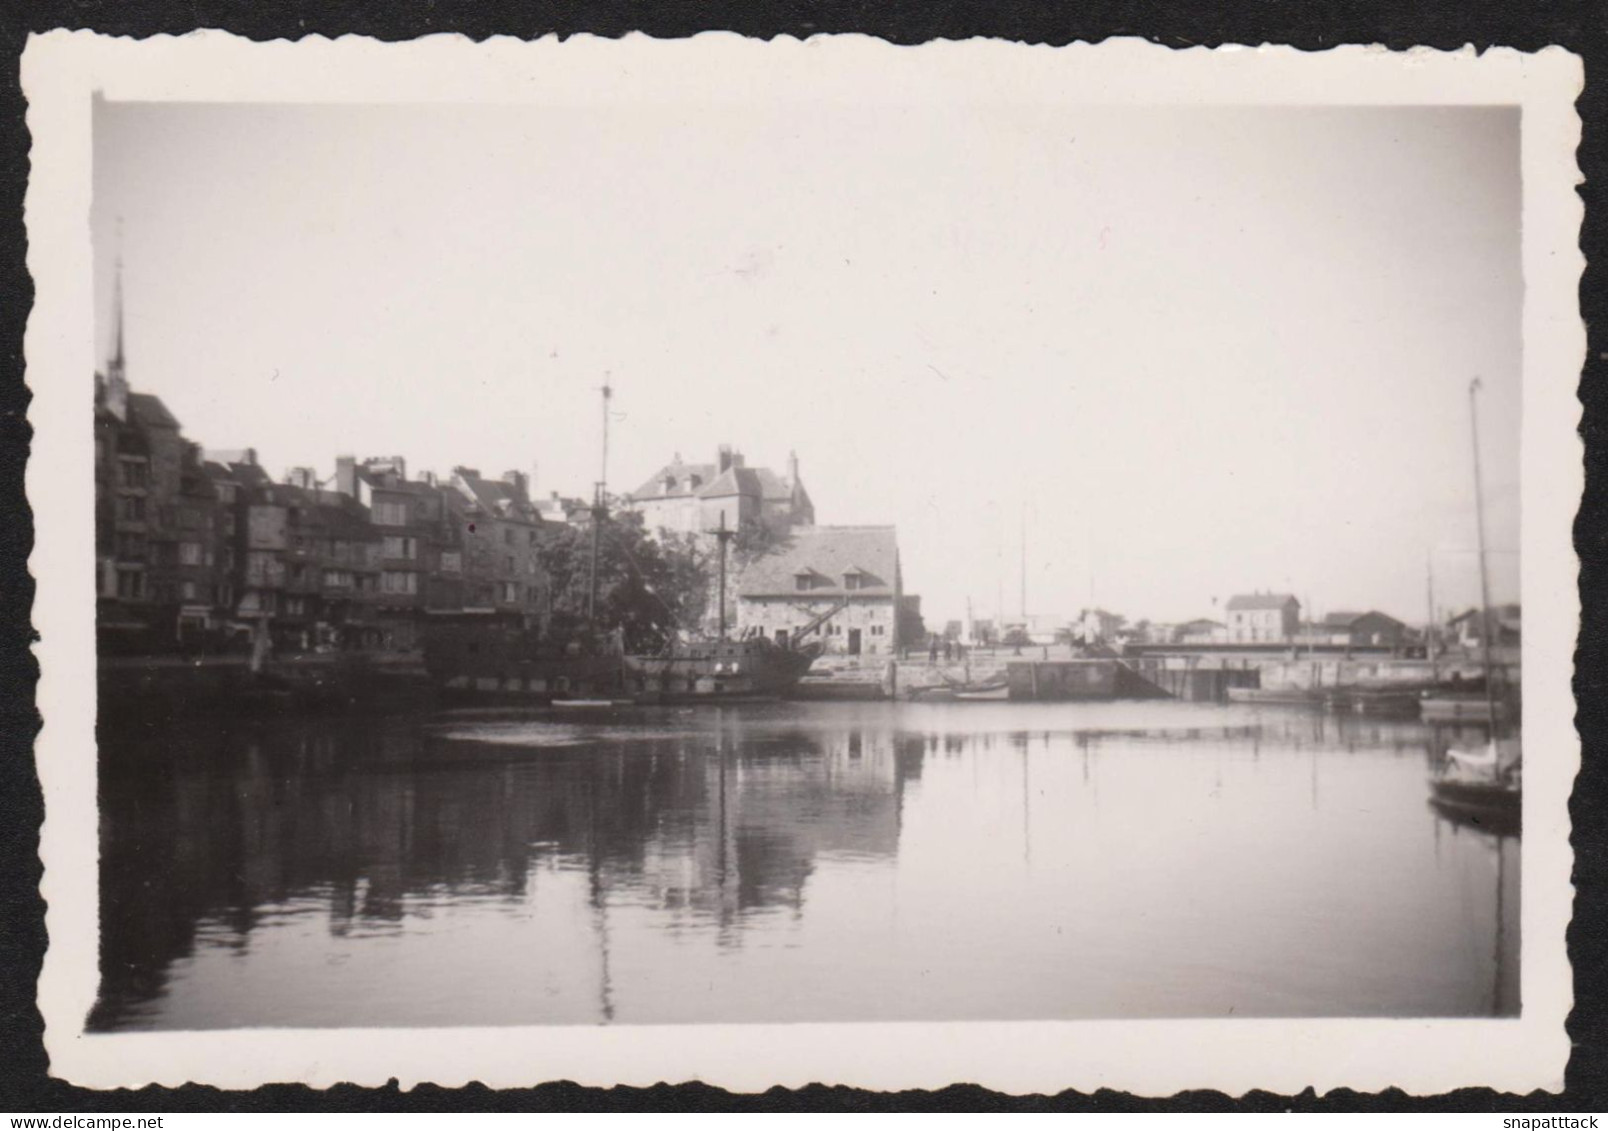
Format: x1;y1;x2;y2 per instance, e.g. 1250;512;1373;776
93;103;1523;621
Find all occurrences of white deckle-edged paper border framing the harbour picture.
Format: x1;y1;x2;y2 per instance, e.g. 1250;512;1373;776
23;32;1585;1096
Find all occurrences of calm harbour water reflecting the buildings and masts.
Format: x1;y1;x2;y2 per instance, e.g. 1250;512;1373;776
90;703;1520;1030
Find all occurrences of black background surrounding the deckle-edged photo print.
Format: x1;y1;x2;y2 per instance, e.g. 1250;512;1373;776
0;0;1608;1115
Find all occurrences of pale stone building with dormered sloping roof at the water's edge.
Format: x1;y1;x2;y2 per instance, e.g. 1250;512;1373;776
736;526;904;656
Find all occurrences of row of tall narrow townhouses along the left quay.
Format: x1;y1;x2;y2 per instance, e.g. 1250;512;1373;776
95;362;584;653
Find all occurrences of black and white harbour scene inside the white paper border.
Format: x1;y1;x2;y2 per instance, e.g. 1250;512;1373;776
25;35;1576;1093
